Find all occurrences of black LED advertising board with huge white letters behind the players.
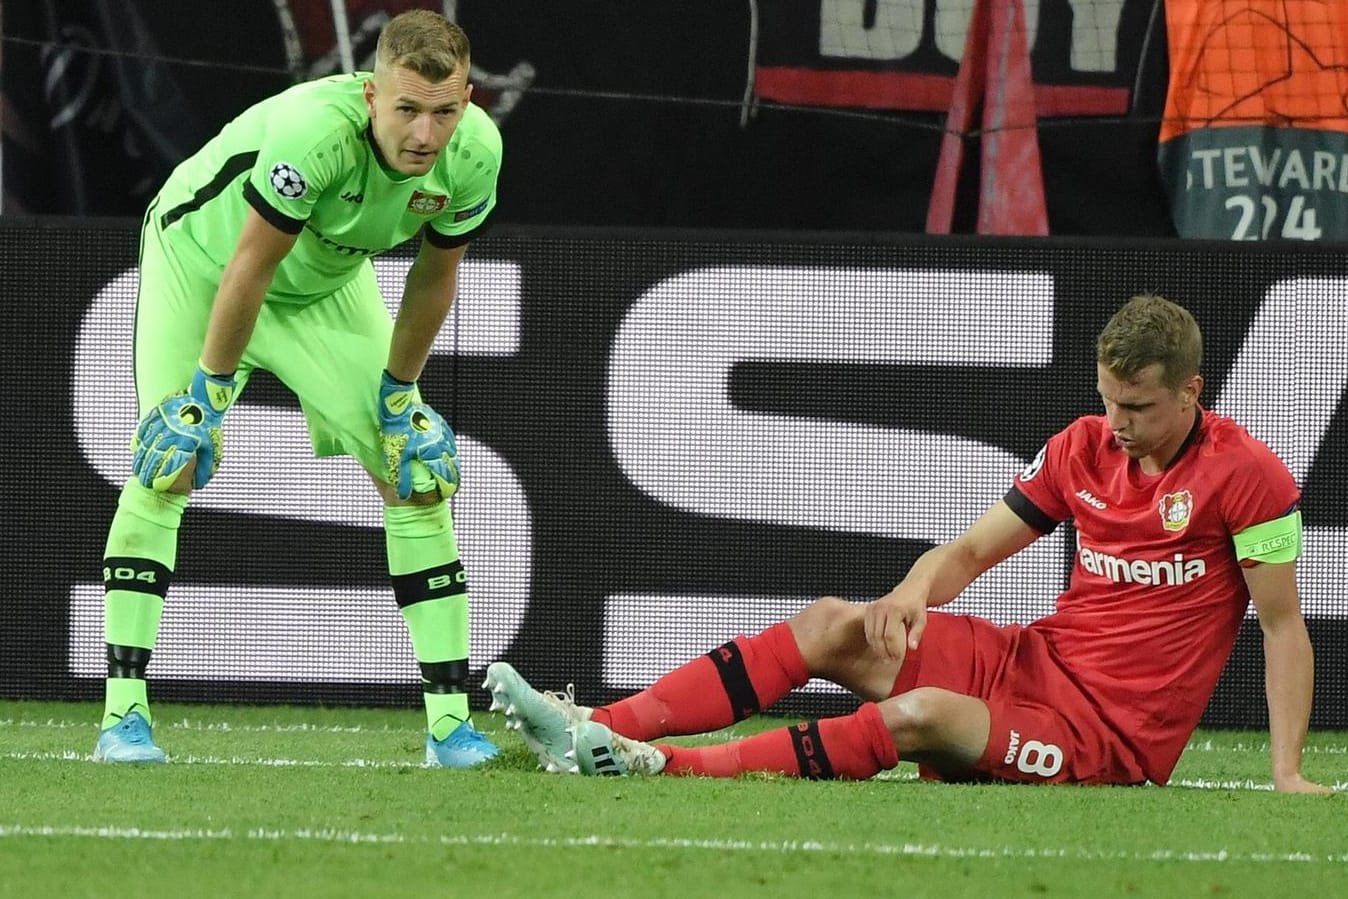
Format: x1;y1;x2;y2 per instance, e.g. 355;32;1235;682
0;217;1348;726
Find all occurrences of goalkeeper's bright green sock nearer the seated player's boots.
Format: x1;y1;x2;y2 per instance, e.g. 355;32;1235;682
384;503;469;740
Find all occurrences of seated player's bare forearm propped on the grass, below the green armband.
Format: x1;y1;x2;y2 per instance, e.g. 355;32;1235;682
1264;616;1316;786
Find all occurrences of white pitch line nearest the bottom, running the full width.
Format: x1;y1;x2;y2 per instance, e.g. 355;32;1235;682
0;824;1348;865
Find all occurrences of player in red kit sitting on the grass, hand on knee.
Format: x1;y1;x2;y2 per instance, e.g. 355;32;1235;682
484;295;1329;793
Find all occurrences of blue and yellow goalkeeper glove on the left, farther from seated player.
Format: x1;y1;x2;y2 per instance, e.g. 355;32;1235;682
131;365;237;491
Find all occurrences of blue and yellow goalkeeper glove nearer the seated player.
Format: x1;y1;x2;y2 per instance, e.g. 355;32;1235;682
379;369;458;500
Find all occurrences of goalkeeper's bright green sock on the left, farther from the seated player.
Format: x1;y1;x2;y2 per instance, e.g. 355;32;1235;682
102;480;187;728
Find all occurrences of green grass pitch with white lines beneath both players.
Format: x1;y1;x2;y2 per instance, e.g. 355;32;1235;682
0;702;1348;899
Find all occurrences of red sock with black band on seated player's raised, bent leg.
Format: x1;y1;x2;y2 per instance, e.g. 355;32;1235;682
594;621;810;740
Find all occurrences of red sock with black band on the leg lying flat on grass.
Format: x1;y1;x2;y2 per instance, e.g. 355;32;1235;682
661;702;899;780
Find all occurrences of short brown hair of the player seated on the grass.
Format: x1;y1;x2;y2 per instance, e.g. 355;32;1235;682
1096;294;1202;392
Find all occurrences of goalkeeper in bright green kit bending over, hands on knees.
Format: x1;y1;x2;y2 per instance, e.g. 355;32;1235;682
94;9;501;767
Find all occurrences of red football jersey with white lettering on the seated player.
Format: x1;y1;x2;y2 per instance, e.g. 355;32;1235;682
1007;410;1301;783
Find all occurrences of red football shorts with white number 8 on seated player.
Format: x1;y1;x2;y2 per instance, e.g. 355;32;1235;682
891;612;1147;783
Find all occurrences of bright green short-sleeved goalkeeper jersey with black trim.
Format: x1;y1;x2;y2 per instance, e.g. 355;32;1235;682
150;73;501;303
